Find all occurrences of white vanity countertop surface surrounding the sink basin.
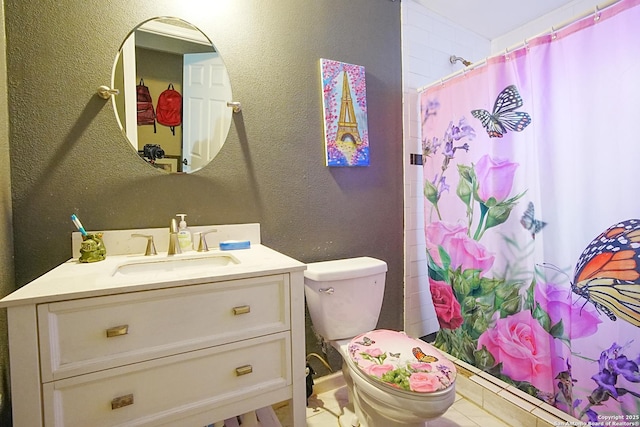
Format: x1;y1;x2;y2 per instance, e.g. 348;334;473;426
0;243;306;307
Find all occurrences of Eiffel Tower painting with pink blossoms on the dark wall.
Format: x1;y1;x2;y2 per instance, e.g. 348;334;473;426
320;59;369;166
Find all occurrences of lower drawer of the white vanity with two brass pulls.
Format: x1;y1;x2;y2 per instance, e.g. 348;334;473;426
43;332;291;427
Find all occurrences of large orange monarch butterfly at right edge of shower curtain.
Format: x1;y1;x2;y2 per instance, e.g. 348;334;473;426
571;219;640;327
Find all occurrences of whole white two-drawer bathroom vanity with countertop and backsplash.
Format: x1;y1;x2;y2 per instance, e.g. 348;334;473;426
0;225;306;427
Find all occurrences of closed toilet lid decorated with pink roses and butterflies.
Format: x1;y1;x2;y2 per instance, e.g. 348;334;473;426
348;329;456;393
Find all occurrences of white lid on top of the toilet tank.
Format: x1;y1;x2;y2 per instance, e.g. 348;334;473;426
304;257;387;282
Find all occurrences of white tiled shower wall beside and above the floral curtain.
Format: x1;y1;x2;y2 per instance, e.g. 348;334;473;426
402;0;602;337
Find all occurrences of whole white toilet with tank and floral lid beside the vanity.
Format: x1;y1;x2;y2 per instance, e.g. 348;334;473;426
304;257;456;427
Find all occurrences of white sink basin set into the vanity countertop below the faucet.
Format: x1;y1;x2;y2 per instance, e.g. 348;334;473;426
113;254;240;276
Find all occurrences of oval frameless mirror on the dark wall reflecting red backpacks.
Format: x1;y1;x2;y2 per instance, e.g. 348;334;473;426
112;17;233;173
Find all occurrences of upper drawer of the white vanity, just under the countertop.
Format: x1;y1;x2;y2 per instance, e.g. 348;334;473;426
38;275;290;382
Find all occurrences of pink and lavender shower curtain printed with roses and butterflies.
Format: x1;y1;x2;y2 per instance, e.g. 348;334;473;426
420;0;640;425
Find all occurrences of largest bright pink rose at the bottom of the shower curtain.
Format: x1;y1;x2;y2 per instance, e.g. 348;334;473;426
478;311;553;393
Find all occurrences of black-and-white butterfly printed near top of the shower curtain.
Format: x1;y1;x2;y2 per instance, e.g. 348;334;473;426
471;85;531;138
